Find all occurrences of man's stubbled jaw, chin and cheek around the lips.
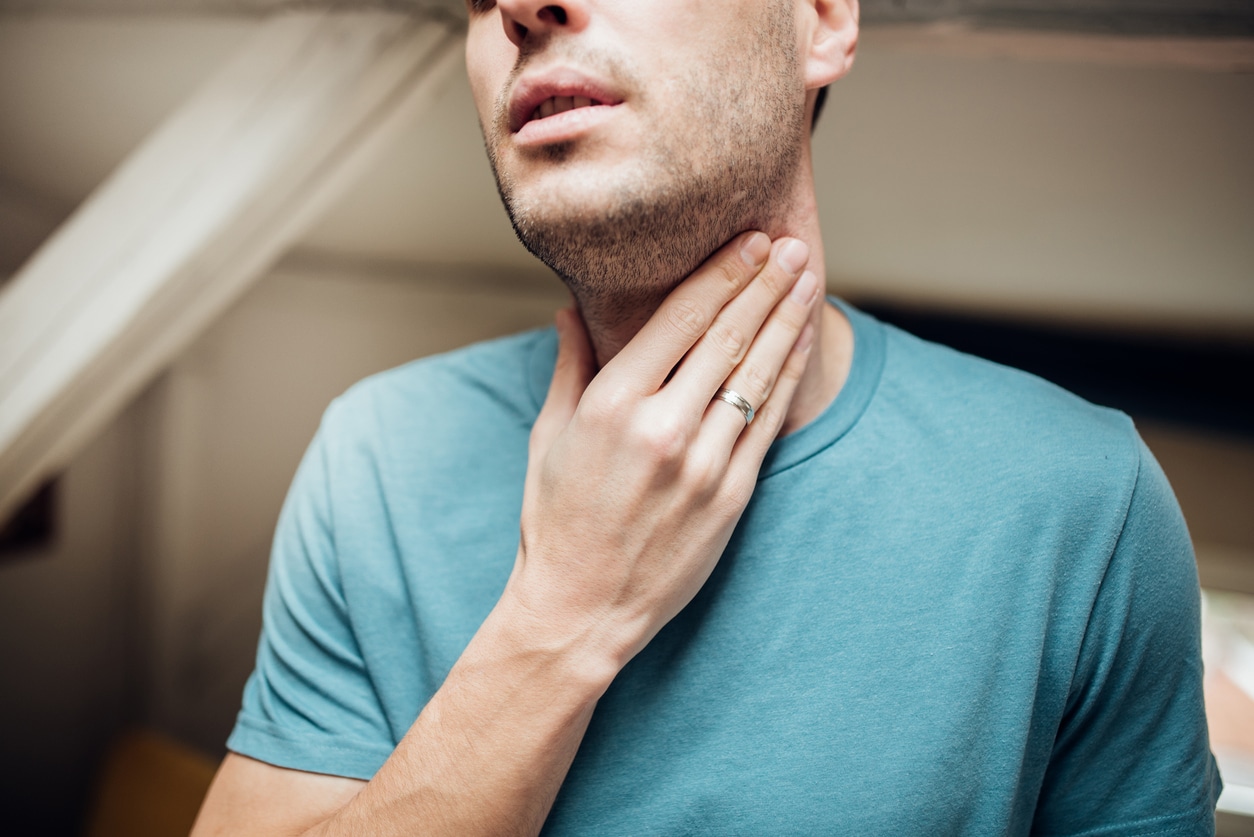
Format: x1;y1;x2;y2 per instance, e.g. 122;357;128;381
479;0;806;336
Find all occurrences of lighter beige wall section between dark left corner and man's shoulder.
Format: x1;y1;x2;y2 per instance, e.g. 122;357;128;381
131;257;566;752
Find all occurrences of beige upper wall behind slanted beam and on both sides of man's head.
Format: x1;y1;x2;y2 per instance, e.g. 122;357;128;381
0;15;1254;336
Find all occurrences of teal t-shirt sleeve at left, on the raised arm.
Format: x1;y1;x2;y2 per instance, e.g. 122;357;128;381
227;407;394;779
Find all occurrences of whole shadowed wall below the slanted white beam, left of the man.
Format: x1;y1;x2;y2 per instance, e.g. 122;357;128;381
0;264;566;833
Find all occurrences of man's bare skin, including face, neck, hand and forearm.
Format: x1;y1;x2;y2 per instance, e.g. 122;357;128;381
193;0;856;837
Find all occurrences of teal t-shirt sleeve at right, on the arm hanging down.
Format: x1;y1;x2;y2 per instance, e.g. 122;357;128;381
1032;439;1221;837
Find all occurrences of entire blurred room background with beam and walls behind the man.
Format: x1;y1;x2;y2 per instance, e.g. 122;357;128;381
0;0;1254;834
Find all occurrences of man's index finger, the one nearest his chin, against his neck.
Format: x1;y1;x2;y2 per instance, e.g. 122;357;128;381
606;232;772;395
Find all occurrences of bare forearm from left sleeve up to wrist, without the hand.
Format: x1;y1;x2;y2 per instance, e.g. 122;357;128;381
193;589;611;836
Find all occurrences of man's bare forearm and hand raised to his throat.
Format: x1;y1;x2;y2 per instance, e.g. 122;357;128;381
185;233;819;837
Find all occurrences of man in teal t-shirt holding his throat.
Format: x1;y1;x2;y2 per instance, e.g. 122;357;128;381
190;0;1219;834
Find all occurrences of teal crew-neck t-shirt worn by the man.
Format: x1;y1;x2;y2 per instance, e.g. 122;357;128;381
227;304;1220;837
